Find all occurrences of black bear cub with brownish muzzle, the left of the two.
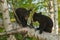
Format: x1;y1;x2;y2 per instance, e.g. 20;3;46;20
14;8;30;27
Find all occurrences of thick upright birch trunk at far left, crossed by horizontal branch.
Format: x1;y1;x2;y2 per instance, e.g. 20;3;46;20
1;0;16;40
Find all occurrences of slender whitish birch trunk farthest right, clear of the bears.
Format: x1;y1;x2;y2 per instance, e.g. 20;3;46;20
53;0;58;34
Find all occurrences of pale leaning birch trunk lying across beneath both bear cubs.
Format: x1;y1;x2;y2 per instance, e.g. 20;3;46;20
0;28;60;40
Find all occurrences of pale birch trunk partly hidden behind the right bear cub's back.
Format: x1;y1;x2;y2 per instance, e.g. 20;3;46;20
48;0;54;33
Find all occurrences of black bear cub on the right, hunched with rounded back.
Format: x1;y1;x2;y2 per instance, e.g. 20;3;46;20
33;12;53;34
